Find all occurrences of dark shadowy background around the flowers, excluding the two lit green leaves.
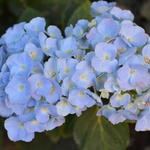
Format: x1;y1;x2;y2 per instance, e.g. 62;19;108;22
0;0;150;150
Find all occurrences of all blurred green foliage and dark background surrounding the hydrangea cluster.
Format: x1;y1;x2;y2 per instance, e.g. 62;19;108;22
0;0;150;150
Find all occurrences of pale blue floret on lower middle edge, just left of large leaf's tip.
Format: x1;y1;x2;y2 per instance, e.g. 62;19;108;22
68;89;96;108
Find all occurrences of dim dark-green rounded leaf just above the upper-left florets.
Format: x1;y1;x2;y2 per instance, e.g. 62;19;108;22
18;7;42;22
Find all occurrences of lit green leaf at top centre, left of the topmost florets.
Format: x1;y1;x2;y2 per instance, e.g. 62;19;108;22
68;0;91;24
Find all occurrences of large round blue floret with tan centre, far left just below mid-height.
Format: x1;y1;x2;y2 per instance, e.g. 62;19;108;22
5;76;31;104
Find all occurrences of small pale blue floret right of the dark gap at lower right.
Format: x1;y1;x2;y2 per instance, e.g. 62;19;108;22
110;93;130;107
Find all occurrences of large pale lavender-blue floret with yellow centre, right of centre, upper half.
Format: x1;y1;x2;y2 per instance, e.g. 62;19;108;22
92;43;118;73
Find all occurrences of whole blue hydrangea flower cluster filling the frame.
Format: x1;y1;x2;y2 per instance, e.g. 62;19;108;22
0;1;150;142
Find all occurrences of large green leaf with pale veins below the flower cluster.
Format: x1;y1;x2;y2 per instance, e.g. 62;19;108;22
74;107;129;150
